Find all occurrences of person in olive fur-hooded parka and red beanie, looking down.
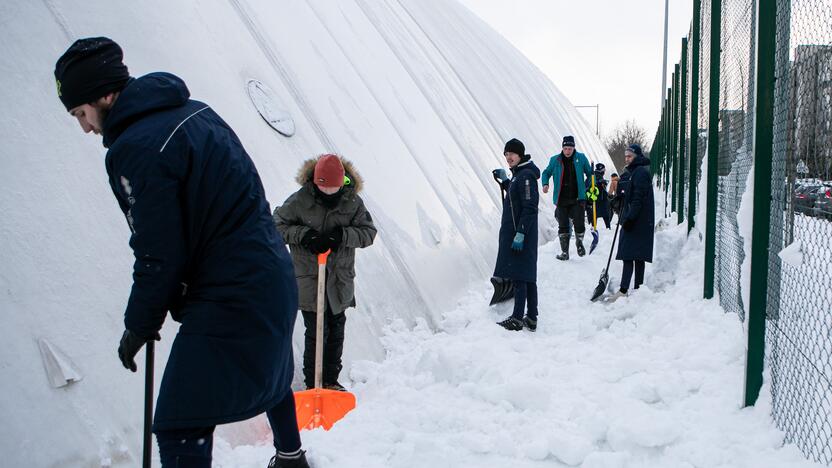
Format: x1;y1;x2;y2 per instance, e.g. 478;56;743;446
274;154;376;391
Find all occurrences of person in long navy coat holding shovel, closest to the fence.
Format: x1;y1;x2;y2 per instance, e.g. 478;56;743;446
611;144;655;300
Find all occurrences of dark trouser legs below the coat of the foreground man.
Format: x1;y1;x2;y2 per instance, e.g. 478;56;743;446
156;391;300;468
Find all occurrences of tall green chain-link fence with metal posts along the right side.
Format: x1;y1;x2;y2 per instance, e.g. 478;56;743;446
651;0;832;464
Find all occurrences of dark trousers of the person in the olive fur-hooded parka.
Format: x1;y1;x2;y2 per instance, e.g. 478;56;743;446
301;304;347;388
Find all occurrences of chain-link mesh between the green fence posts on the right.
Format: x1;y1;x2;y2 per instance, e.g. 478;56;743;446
657;0;832;465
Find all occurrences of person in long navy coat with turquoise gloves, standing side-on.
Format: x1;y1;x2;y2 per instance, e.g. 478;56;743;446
493;138;540;331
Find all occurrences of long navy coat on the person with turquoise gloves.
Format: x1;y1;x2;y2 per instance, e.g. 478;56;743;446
494;161;540;283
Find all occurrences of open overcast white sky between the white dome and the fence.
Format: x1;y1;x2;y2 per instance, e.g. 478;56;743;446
461;0;693;146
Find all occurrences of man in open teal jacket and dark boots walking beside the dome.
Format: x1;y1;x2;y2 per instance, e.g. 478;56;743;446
542;135;592;260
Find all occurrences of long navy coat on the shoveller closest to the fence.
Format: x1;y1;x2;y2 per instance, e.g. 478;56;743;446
615;156;655;262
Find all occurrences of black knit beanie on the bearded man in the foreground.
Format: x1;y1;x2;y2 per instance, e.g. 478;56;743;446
55;37;130;110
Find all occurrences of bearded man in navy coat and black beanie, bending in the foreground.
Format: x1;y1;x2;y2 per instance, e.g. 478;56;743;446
55;38;308;468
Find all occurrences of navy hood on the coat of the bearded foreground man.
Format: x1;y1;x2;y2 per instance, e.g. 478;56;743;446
102;72;191;148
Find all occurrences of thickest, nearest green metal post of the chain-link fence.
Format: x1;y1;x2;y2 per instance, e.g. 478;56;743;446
745;0;777;406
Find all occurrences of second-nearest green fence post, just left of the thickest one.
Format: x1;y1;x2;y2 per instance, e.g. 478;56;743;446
704;0;722;299
